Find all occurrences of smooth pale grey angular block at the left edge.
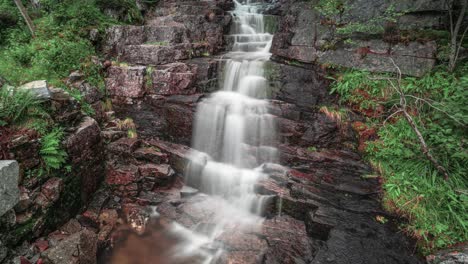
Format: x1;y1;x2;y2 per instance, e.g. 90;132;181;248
0;160;20;217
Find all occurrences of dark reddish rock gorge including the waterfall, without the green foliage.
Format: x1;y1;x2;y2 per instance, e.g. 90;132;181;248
0;0;467;264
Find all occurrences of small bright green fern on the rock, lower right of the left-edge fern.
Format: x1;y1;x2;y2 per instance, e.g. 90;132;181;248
40;128;67;171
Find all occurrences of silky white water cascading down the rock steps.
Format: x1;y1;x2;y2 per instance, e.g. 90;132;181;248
162;1;277;263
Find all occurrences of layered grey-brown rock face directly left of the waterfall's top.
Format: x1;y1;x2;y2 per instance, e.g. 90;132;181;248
103;1;230;65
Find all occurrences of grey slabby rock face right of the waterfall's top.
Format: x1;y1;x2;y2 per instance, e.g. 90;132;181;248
272;0;446;76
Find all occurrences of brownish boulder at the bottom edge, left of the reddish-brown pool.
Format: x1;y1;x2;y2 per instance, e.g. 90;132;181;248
41;229;97;264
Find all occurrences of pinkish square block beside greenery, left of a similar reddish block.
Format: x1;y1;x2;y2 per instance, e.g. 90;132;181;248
106;66;146;98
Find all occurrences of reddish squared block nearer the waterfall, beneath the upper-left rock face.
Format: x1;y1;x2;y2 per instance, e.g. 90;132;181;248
151;63;197;95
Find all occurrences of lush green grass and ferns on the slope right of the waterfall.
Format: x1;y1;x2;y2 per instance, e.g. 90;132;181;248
332;64;468;253
